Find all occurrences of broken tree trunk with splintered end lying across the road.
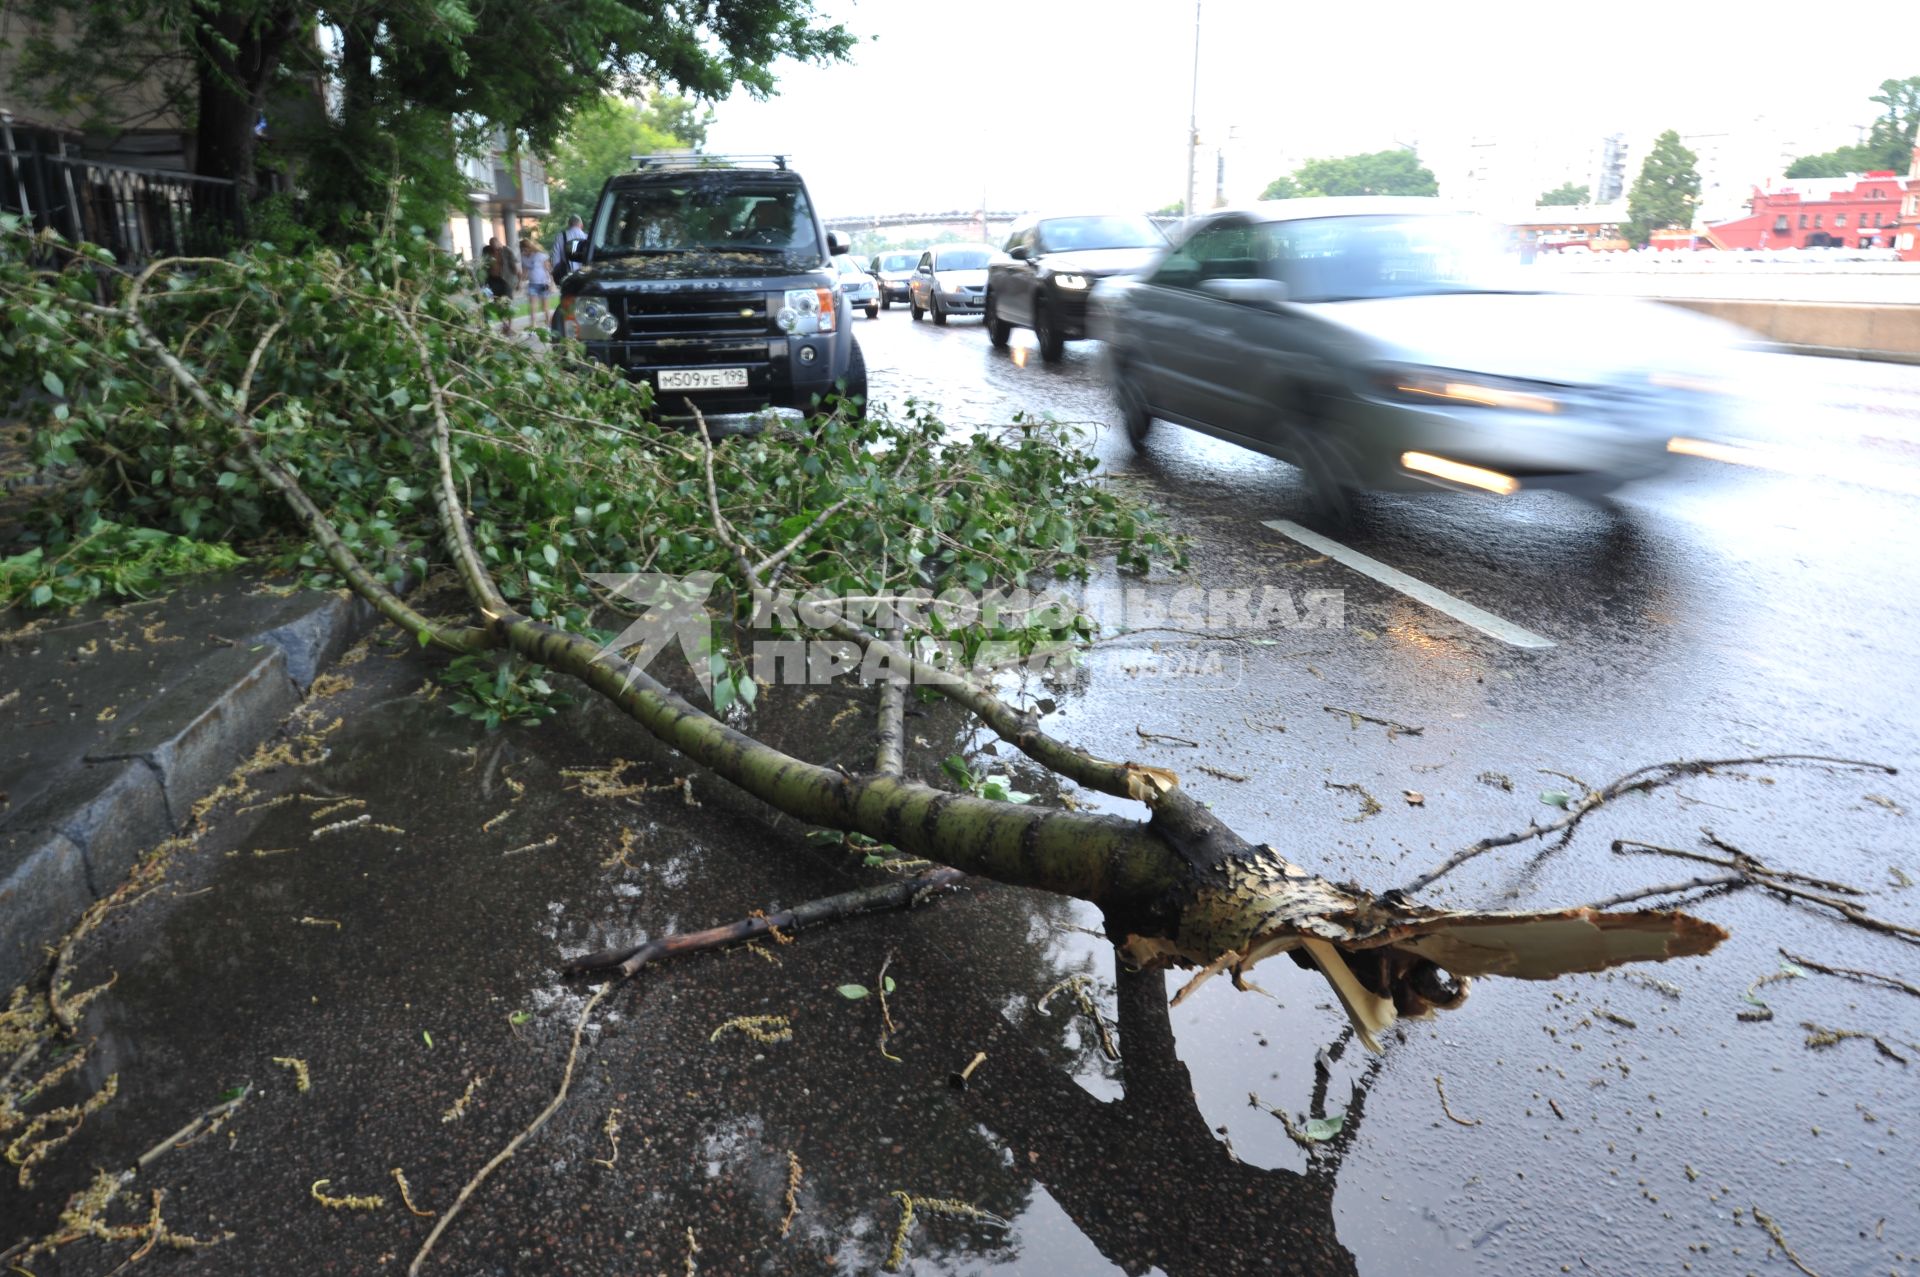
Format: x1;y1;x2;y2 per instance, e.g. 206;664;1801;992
26;243;1724;1048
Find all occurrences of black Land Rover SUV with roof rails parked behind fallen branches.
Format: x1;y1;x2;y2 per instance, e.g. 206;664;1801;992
553;156;866;417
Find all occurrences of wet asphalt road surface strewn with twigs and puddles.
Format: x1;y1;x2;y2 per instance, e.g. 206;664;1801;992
0;309;1920;1277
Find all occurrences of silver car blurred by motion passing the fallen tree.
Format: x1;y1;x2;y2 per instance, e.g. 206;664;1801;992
1091;198;1740;515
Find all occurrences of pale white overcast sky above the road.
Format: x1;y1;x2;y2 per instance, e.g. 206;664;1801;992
708;0;1920;215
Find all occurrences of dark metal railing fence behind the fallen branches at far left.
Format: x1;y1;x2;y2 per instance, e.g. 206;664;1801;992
0;133;246;265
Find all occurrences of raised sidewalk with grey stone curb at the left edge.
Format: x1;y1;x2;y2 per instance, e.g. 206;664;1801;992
0;574;372;989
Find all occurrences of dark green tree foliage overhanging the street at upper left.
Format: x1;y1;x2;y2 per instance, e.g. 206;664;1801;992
12;0;852;229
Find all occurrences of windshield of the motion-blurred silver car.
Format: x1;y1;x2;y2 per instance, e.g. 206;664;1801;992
1250;213;1505;301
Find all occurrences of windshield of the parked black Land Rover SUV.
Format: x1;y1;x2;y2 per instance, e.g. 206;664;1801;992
591;169;820;257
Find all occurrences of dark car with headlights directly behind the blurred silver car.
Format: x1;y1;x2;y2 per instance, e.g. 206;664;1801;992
987;213;1167;363
